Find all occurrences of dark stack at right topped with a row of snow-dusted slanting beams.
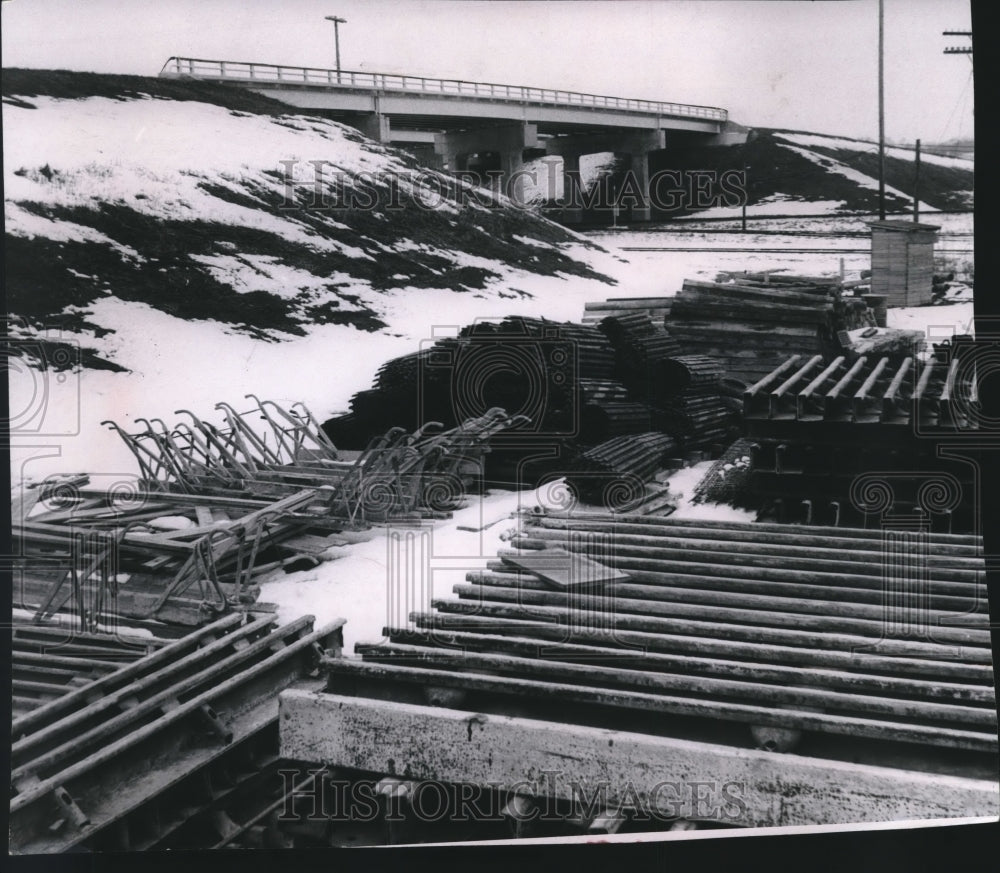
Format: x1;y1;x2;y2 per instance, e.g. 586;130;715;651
744;345;979;530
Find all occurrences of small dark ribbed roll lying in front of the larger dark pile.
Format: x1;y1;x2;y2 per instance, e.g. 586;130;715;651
566;432;677;509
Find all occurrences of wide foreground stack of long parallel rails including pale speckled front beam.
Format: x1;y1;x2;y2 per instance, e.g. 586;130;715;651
281;515;1000;826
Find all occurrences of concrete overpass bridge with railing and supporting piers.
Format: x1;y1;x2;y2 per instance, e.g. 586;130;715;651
160;57;745;218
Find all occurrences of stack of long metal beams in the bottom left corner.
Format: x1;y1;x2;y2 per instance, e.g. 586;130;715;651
10;615;343;854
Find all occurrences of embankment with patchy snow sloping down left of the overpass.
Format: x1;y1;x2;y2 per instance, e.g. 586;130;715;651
3;71;616;367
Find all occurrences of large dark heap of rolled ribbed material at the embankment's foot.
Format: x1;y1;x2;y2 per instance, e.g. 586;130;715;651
323;316;738;504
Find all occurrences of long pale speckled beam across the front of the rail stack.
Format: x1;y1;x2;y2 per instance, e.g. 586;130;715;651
279;690;1000;827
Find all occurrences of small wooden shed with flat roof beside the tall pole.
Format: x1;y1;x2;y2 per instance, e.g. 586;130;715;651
868;219;941;306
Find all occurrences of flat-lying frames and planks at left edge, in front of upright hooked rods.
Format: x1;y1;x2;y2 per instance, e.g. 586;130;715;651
12;483;346;633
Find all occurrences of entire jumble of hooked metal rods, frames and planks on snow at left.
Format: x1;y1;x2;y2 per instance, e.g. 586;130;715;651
12;398;520;632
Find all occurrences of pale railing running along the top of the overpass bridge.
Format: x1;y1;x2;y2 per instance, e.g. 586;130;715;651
160;57;729;121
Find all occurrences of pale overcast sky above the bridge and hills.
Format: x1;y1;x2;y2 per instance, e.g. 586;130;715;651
2;0;973;142
